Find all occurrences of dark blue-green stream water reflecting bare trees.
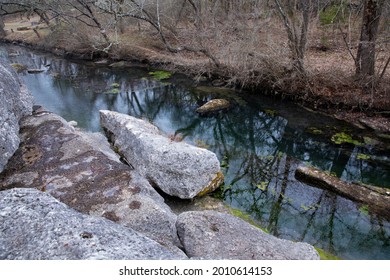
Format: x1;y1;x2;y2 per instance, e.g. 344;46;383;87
0;46;390;259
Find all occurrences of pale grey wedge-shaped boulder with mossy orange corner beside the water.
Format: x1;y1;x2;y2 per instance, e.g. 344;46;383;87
100;110;223;199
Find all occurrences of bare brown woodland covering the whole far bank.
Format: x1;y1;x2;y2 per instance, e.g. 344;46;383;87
0;0;390;116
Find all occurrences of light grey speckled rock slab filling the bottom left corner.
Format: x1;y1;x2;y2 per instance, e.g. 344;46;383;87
0;188;180;260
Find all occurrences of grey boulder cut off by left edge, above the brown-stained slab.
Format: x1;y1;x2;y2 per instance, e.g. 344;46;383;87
0;63;33;172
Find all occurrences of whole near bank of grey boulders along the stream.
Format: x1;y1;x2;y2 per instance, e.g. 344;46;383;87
0;58;320;260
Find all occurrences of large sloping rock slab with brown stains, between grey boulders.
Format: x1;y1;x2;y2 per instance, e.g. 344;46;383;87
0;109;180;252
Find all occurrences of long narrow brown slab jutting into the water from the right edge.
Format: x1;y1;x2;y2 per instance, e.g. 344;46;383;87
295;166;390;220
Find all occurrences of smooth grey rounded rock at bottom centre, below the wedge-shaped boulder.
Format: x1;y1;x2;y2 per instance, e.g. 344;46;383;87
176;211;319;260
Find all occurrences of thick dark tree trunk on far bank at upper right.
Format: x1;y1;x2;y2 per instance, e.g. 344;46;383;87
356;0;384;87
